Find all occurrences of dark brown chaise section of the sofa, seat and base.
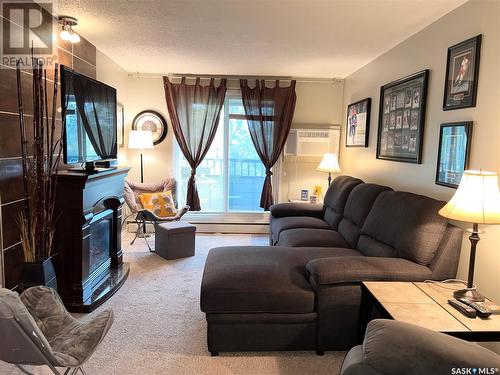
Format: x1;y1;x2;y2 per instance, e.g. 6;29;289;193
201;246;361;354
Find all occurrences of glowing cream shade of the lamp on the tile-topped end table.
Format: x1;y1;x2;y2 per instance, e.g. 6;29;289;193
439;171;500;224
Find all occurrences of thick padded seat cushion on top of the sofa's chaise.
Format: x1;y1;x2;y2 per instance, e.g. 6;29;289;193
201;246;361;313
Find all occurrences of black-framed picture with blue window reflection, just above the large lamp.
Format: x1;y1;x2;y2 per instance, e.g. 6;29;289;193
436;121;472;189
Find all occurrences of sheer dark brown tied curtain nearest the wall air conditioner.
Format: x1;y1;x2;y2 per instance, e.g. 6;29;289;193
240;79;297;211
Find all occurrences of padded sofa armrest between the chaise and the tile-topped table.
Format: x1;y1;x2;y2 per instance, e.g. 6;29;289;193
306;256;432;285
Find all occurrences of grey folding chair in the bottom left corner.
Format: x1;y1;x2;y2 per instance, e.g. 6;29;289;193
0;286;113;374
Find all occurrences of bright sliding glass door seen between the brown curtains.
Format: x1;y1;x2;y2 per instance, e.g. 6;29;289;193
177;90;266;212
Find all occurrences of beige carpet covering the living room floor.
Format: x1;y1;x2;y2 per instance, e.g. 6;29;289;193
0;235;345;375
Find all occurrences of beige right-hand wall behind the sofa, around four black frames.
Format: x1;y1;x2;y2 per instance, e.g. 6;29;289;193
341;0;500;302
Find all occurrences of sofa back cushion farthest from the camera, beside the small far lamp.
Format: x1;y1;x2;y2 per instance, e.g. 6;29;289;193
324;176;363;230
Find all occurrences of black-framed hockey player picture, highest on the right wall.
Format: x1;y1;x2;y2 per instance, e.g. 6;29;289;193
443;35;481;111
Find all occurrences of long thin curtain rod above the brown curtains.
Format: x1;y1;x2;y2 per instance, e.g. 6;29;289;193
129;72;343;84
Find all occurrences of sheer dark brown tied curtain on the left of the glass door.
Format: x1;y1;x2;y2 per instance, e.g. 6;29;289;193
163;77;226;211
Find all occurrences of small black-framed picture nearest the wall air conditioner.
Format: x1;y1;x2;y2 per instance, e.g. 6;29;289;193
345;98;372;147
